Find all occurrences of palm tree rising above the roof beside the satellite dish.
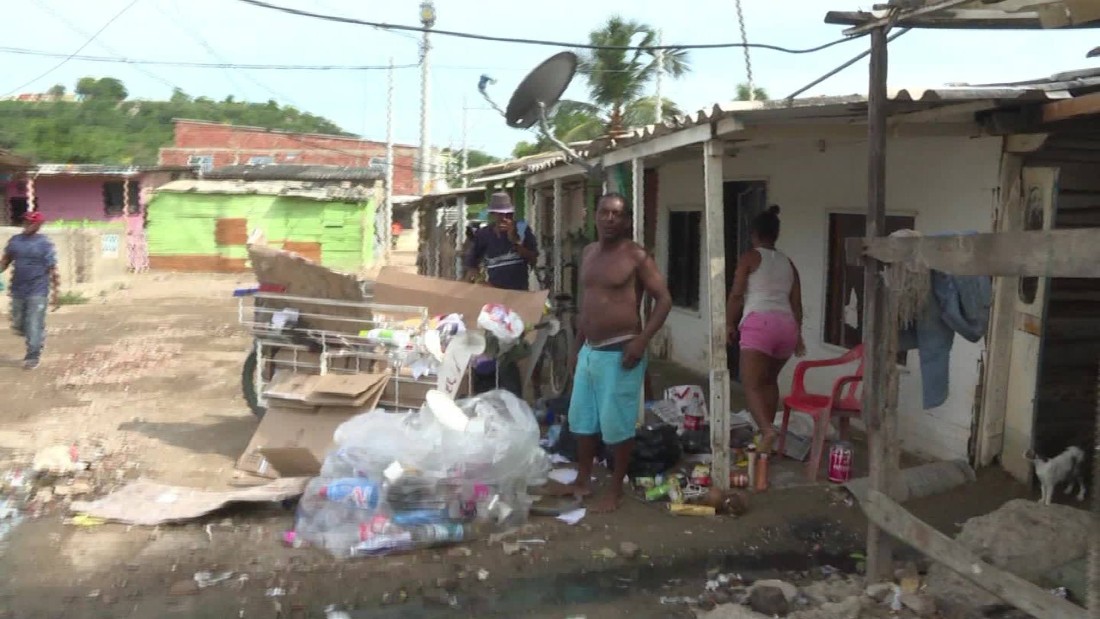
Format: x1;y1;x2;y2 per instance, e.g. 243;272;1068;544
513;15;690;156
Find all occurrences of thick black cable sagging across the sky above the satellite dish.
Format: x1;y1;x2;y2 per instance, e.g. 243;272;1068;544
239;0;865;54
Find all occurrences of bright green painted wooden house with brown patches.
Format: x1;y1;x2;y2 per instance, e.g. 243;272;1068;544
146;179;381;273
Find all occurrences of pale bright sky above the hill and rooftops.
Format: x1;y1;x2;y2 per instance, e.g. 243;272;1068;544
8;0;1100;156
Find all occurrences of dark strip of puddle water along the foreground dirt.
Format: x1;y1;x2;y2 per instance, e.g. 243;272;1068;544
351;552;856;619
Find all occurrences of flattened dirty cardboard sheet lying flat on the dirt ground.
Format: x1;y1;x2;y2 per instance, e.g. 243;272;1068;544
70;477;309;527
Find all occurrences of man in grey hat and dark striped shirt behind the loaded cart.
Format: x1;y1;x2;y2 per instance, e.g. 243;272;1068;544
466;191;539;290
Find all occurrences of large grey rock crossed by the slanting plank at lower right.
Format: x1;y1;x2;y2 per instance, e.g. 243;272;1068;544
925;499;1091;607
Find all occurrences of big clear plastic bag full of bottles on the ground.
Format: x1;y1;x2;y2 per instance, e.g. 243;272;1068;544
287;390;550;557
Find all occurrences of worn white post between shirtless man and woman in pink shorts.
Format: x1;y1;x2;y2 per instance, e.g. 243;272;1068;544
703;140;729;490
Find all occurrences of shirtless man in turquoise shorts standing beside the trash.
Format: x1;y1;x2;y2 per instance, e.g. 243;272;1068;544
568;194;672;512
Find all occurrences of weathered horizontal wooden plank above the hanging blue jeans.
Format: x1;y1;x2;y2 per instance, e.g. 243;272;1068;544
845;228;1100;277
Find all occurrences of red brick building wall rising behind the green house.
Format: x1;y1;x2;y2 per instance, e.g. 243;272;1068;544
158;121;419;196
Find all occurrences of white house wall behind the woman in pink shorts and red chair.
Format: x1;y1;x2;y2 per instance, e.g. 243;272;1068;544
657;137;1001;466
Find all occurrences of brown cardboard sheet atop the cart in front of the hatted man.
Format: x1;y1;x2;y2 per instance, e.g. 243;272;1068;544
374;266;550;329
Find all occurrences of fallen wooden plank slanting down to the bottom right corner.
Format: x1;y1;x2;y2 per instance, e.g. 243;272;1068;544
860;489;1087;619
